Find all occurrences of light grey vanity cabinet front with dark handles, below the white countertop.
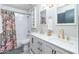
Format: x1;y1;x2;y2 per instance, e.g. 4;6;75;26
30;35;71;54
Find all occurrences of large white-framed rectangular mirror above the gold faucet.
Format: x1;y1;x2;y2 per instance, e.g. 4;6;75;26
56;5;76;25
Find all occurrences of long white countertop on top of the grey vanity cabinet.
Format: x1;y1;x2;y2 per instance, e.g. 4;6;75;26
31;33;78;53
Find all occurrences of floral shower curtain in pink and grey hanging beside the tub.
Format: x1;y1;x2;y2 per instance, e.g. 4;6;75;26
0;9;16;52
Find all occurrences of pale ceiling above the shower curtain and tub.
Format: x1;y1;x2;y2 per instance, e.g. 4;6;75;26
4;4;35;10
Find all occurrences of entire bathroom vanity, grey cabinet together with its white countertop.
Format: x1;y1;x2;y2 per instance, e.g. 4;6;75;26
30;33;78;54
